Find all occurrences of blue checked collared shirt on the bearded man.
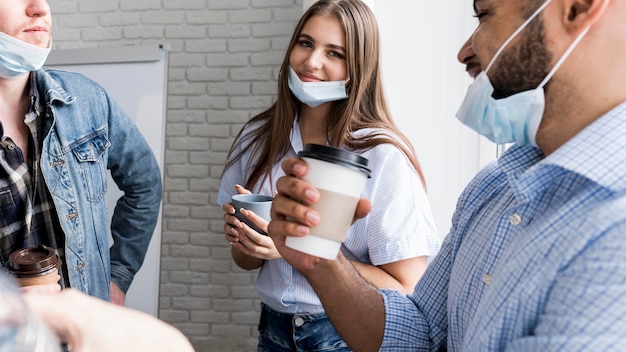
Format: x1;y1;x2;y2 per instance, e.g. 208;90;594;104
381;103;626;352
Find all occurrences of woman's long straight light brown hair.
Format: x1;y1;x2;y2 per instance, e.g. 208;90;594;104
224;0;425;189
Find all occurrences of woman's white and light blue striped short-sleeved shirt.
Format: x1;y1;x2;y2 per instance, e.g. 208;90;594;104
217;119;440;313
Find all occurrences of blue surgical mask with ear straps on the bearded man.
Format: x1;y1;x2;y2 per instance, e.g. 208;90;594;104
456;0;589;146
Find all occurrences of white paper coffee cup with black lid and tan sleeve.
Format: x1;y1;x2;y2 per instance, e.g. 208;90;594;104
285;144;371;260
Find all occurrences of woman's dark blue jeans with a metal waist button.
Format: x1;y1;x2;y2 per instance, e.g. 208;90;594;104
258;304;352;352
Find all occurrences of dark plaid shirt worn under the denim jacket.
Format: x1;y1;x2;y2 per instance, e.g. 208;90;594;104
0;75;67;286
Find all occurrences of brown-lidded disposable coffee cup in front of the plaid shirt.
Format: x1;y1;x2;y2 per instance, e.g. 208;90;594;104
7;245;61;286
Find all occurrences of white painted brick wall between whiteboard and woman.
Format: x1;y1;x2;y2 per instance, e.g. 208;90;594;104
48;0;302;352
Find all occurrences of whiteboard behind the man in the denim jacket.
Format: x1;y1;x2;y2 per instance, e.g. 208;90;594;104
45;44;169;317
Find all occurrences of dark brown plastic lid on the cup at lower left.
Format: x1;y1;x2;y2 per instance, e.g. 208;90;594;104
7;244;61;277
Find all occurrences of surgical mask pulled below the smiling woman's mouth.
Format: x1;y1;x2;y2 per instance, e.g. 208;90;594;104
288;66;348;108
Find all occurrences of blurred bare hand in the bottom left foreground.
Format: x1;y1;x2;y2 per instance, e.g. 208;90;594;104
23;289;194;352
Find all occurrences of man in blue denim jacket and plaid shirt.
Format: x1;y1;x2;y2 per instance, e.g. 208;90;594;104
0;0;162;304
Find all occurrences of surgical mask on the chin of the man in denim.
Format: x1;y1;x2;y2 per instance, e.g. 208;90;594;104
0;32;52;79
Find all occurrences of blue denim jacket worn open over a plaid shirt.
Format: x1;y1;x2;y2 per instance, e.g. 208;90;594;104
34;68;162;300
